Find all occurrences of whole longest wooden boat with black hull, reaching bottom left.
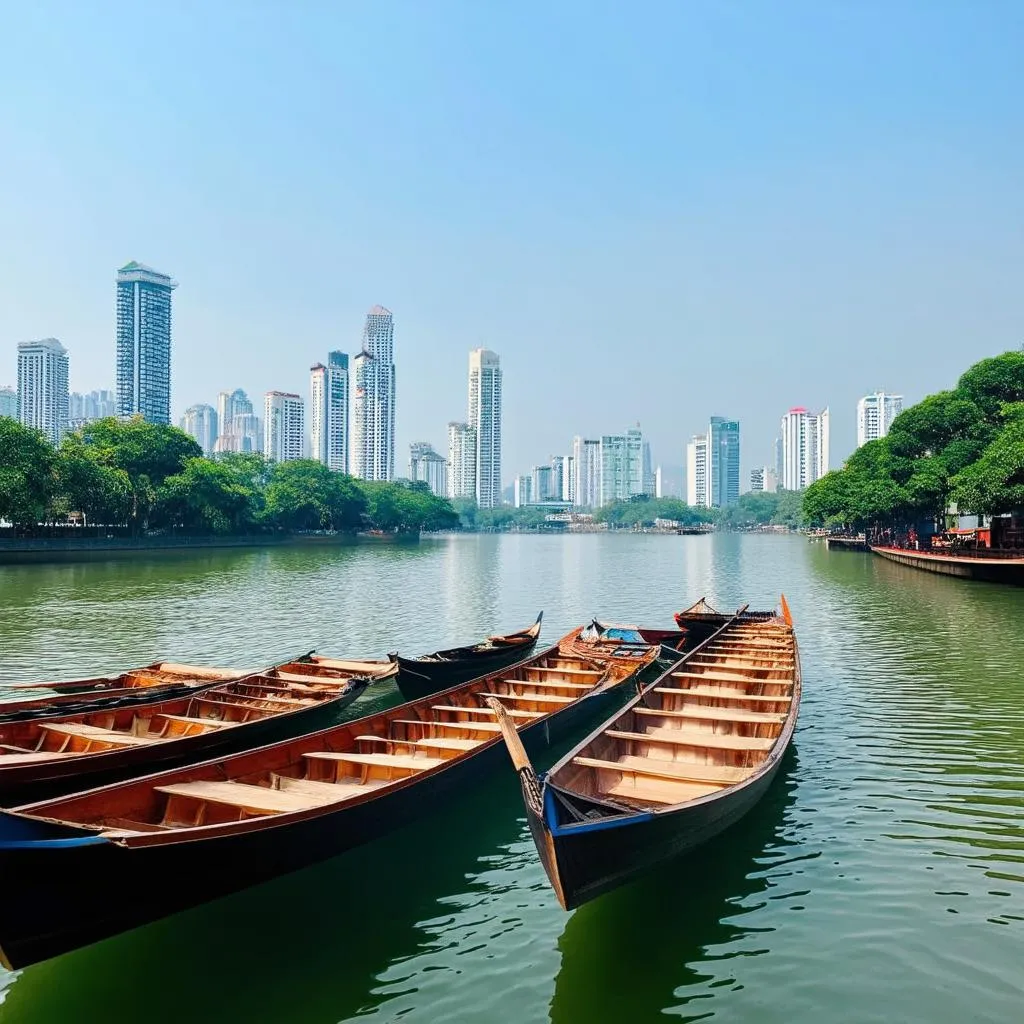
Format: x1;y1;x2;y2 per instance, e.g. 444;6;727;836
0;630;657;968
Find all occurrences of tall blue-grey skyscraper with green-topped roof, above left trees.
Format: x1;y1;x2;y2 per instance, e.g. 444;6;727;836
117;260;177;423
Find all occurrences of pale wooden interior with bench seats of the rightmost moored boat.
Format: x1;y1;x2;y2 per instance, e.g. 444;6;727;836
549;620;799;820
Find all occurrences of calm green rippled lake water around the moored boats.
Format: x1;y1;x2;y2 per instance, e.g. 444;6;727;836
0;535;1024;1024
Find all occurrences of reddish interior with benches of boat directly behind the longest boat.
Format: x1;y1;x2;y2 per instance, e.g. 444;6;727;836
0;674;342;777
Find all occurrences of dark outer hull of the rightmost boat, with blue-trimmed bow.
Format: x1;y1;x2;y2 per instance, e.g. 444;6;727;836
526;754;782;910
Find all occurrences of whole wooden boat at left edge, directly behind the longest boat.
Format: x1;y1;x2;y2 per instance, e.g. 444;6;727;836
0;673;369;807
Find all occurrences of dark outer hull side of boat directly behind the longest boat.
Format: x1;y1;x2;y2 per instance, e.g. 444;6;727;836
0;684;365;811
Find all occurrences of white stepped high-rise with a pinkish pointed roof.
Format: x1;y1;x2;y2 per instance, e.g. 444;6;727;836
349;306;395;480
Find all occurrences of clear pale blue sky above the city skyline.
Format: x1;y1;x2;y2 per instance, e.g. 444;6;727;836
0;0;1024;481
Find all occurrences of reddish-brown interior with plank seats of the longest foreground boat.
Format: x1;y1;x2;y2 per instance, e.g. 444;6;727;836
22;648;637;834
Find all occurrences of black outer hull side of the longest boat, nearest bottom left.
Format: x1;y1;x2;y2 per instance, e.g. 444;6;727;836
0;686;623;969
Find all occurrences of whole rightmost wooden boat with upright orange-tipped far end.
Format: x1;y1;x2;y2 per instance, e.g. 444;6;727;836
493;598;800;910
